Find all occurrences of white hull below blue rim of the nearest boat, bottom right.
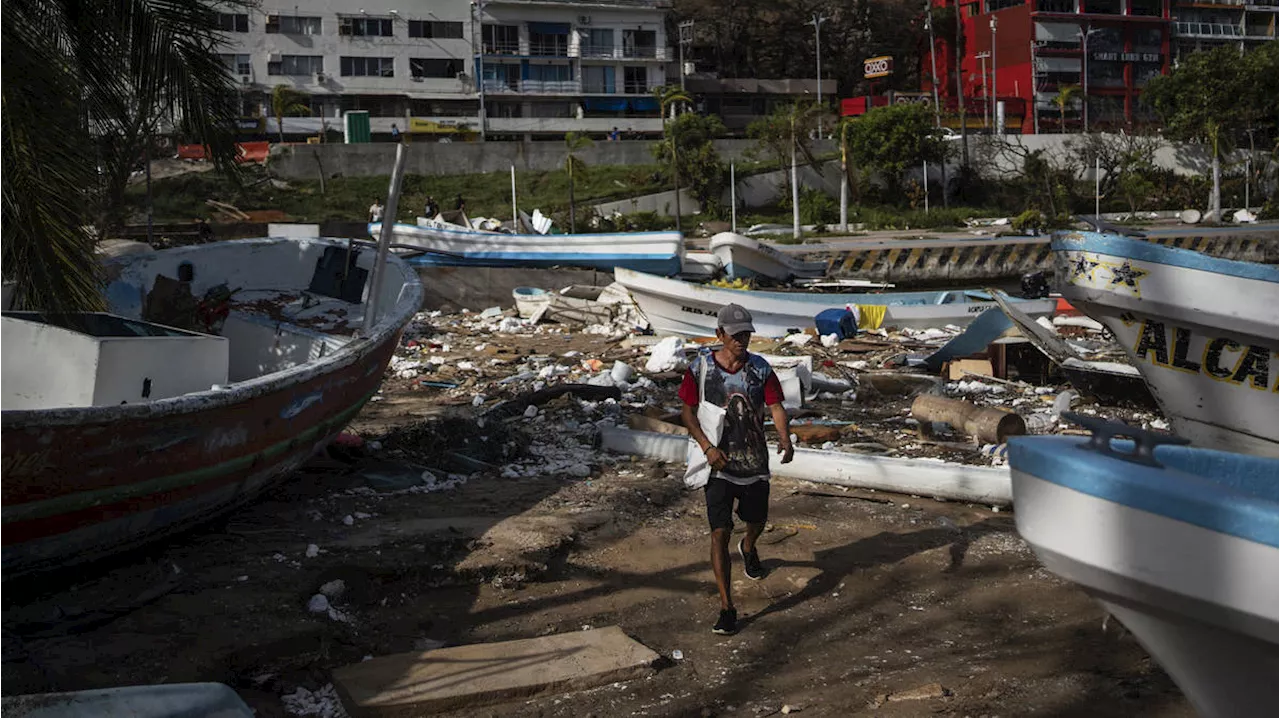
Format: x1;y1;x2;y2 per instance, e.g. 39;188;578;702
1012;468;1280;718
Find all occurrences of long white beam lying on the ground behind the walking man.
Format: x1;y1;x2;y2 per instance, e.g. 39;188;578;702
600;427;1014;506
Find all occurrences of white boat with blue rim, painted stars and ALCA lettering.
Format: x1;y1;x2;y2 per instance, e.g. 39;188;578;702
1052;232;1280;456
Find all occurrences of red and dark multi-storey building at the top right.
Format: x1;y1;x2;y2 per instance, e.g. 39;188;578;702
920;0;1171;133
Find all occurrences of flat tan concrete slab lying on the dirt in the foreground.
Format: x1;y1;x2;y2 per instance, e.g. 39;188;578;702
333;626;658;718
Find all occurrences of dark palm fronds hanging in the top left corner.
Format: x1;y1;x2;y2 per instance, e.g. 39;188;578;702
0;0;237;312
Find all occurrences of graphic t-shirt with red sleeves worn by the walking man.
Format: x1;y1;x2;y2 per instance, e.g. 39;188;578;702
680;349;782;484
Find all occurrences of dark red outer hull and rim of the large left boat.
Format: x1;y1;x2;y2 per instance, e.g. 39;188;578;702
0;239;421;578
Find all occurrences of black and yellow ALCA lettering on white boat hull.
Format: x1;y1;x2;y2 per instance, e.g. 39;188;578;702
1133;320;1280;392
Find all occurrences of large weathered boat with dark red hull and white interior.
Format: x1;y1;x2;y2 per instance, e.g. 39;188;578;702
0;239;422;576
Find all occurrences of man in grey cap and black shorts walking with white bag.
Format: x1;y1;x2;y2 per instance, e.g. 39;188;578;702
680;305;795;635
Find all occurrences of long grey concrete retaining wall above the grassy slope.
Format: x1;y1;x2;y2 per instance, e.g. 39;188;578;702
268;140;836;179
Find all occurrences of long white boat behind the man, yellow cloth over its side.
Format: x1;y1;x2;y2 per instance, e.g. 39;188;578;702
613;267;1056;337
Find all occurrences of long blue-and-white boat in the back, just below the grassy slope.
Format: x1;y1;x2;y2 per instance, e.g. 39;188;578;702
369;218;685;276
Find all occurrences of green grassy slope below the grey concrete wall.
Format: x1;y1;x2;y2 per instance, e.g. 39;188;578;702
127;165;664;223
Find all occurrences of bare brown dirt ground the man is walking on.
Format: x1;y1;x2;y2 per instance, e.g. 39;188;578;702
0;311;1193;718
